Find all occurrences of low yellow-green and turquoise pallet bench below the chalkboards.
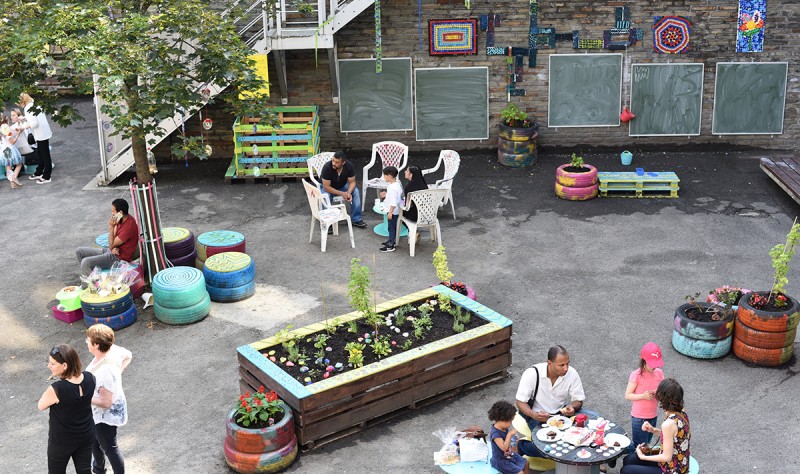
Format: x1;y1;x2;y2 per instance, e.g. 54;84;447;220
597;171;680;198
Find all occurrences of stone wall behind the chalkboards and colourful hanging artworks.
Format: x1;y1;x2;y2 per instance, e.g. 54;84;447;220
164;0;800;157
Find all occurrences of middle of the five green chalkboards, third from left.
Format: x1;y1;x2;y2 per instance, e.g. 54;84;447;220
547;53;622;127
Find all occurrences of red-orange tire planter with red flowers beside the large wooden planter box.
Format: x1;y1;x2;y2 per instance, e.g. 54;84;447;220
224;385;297;474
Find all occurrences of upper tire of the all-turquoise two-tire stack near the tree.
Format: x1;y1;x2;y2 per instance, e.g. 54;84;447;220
151;267;207;309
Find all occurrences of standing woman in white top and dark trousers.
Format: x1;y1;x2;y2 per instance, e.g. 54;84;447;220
86;324;133;474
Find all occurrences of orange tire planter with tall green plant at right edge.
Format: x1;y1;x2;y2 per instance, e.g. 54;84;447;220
733;219;800;366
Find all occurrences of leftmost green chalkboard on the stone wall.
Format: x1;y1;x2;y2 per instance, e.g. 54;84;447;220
338;58;414;132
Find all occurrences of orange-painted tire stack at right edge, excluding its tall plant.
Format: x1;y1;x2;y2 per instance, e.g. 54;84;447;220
733;291;800;367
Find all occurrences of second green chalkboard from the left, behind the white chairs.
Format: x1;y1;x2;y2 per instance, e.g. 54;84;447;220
414;67;489;141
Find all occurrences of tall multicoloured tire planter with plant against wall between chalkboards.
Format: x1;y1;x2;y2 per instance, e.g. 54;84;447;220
497;103;539;168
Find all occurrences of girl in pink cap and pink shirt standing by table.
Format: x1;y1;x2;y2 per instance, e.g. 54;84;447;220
625;342;664;453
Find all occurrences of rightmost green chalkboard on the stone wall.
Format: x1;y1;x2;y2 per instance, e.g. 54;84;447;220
711;63;789;135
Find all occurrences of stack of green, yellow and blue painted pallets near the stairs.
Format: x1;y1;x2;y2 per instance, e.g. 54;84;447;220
226;106;320;178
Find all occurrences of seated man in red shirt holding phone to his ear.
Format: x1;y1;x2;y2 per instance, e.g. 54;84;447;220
75;199;139;275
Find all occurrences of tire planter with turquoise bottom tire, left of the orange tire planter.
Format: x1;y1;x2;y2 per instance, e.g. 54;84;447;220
672;293;734;359
